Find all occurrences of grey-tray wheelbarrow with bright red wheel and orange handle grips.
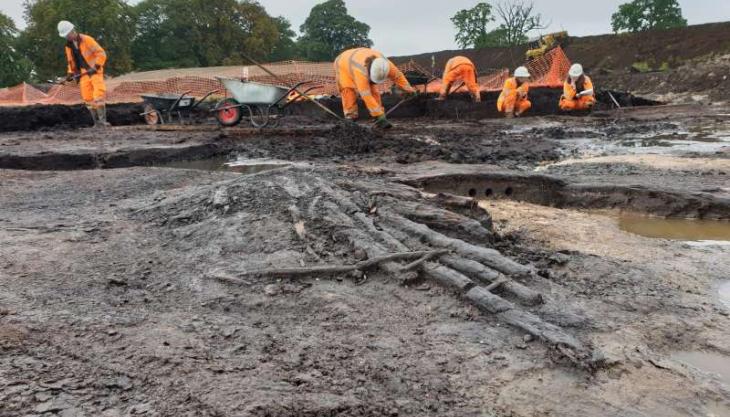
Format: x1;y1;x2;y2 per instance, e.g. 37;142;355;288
211;77;321;128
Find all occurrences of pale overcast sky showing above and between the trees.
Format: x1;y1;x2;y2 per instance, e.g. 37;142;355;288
0;0;730;56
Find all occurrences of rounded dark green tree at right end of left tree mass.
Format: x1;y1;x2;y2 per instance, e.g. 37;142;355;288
299;0;373;61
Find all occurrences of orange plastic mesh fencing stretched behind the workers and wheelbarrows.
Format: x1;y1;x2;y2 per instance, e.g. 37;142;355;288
0;47;571;106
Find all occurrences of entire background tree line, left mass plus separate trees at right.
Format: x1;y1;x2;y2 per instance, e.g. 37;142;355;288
0;0;687;87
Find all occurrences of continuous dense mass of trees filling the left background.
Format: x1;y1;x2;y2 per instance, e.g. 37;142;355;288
0;0;372;87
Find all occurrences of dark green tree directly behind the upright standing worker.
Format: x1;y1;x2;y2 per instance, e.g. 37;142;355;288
18;0;134;80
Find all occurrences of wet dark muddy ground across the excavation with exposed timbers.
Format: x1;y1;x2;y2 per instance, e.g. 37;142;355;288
0;101;730;417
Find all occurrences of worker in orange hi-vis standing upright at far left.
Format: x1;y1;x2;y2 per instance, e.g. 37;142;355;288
58;20;109;127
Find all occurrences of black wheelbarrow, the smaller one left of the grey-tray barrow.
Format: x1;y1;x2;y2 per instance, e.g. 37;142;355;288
140;89;221;125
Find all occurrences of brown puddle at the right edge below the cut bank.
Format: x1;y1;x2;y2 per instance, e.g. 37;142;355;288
618;213;730;241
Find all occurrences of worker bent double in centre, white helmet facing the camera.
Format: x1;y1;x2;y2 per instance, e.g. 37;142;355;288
335;48;418;129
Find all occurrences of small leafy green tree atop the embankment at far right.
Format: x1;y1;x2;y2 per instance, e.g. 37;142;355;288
611;0;687;33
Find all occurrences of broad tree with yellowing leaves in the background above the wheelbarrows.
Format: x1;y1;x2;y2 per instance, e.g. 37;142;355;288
132;0;280;70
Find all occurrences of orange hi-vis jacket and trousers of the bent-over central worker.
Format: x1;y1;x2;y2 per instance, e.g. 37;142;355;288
335;48;414;117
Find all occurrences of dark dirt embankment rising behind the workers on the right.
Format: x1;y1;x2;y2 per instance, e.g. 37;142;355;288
394;23;730;102
